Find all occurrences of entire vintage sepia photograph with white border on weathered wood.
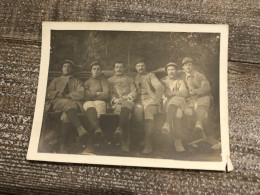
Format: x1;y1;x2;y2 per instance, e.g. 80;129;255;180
27;22;232;171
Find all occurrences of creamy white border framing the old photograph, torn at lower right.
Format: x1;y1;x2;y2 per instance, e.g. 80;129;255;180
27;22;233;171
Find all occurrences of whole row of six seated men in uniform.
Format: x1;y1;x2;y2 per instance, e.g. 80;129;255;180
46;57;220;154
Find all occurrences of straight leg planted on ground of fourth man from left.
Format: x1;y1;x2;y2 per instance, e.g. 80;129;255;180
142;105;158;154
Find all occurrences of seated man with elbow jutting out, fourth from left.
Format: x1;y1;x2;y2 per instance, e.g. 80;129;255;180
134;58;164;154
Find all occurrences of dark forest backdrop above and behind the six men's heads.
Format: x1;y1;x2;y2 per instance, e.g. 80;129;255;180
50;30;220;107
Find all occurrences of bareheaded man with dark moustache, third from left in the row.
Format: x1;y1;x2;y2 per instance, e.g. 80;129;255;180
108;61;137;152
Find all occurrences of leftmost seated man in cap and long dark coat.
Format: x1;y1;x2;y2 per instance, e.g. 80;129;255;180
45;60;87;153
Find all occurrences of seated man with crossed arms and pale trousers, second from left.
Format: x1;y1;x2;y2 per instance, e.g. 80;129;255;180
83;61;109;146
